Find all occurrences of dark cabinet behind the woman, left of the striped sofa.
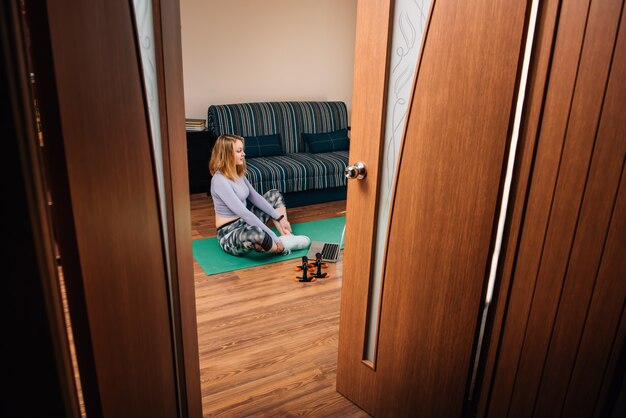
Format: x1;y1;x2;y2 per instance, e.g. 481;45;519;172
187;131;215;193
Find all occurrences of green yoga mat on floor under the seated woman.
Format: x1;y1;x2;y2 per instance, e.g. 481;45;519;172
192;216;346;276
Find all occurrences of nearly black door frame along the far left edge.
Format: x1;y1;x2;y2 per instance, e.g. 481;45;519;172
0;1;80;417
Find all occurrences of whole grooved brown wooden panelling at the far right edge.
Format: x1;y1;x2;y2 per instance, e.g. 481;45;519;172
487;1;626;417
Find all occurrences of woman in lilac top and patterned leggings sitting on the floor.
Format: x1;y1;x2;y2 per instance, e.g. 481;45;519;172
209;135;311;256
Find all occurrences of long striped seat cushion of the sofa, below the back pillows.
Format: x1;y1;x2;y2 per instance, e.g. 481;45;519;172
246;151;348;194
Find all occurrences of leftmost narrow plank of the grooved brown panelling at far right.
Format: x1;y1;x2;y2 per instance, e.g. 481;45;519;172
489;2;589;417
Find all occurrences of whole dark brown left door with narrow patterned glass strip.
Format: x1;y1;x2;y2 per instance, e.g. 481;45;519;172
22;0;201;417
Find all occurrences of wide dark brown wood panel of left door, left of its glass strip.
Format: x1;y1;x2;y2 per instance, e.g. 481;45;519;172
32;1;178;417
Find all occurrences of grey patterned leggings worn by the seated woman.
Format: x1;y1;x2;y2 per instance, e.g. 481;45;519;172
217;189;285;256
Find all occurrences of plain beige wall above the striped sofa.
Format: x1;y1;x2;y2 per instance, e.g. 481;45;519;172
180;0;356;118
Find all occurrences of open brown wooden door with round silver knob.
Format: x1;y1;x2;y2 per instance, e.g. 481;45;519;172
337;0;529;417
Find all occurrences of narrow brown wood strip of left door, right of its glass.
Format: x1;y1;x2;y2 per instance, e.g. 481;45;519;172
153;0;202;417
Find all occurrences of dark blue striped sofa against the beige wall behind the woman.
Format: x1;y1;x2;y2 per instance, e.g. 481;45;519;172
207;102;348;207
